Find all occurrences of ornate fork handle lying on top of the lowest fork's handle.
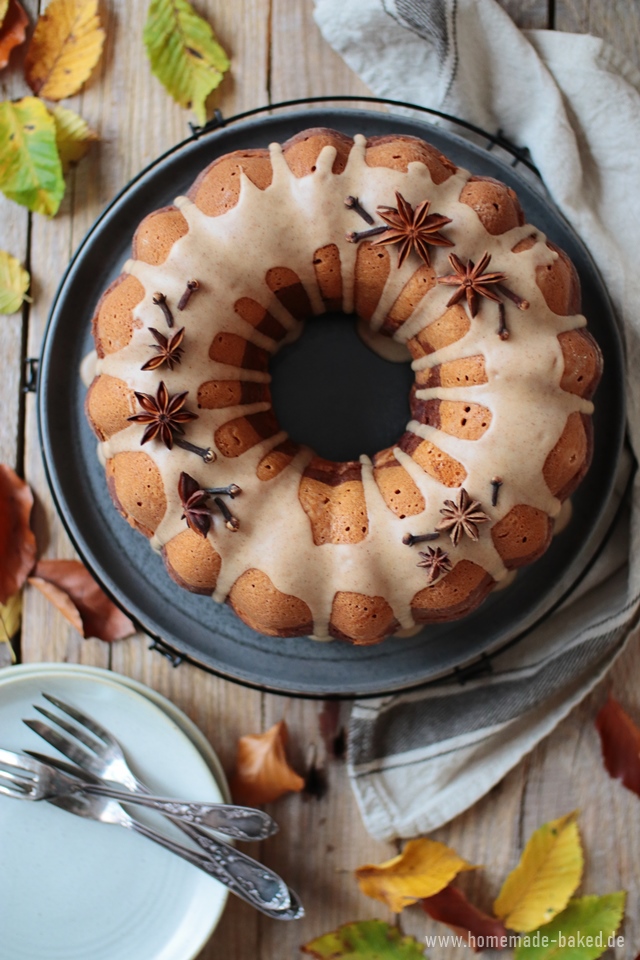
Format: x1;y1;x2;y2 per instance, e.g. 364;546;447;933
130;819;291;919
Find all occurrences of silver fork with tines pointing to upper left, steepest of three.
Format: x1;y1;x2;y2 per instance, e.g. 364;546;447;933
24;693;304;920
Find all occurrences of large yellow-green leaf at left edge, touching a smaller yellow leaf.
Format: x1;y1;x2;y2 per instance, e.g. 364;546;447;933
0;97;64;217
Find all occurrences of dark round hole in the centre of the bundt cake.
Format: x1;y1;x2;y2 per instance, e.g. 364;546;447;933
270;313;413;460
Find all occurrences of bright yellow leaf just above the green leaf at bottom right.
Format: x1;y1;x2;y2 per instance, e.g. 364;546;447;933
493;812;584;933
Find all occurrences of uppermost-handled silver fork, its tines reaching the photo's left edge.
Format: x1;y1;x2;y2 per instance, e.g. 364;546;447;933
0;748;278;840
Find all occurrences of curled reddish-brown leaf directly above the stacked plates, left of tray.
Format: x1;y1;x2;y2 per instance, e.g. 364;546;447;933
29;560;136;643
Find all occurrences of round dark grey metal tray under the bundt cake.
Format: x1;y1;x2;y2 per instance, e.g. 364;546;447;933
38;107;625;697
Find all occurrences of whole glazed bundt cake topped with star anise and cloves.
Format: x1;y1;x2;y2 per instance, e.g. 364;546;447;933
86;129;602;644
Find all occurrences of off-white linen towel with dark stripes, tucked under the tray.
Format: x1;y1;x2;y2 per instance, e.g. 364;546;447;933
315;0;640;840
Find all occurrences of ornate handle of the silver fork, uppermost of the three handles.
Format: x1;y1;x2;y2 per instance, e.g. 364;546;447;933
82;784;277;840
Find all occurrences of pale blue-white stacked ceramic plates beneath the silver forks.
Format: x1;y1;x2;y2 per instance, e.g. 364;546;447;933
0;665;227;960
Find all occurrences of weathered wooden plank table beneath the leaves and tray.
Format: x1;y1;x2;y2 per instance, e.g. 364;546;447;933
0;0;640;960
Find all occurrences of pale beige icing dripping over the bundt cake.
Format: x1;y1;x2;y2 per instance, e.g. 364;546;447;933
92;135;592;639
